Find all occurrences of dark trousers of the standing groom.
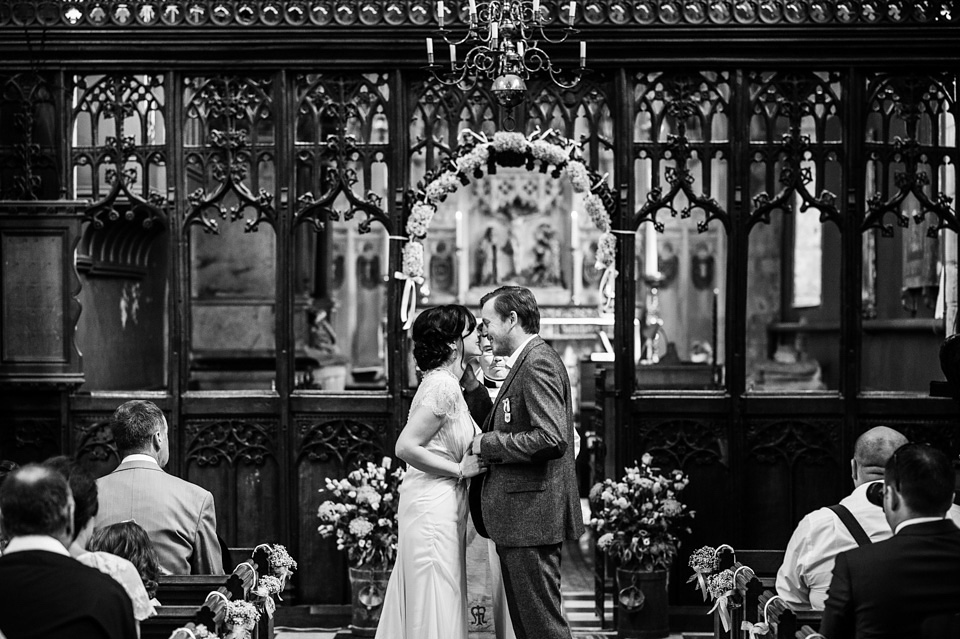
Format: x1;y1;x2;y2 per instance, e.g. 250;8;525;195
497;544;572;639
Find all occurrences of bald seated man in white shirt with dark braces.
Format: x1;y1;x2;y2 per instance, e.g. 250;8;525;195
777;426;960;610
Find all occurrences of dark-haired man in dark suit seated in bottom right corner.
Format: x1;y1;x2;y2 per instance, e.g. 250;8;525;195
820;444;960;639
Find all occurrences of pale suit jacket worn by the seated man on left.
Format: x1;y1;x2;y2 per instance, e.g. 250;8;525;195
94;461;223;575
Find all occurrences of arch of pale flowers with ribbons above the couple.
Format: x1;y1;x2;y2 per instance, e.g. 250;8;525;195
394;127;617;329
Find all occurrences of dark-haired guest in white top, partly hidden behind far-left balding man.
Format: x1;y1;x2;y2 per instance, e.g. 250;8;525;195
43;455;157;627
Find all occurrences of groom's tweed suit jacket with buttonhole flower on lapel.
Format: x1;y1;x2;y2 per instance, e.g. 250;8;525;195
480;336;583;546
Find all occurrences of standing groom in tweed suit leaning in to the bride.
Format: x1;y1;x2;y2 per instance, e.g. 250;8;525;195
471;286;583;639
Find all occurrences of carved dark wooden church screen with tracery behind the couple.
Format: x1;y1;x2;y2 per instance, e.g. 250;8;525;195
0;0;960;620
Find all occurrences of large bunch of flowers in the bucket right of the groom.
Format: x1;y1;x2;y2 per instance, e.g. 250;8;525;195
590;453;694;571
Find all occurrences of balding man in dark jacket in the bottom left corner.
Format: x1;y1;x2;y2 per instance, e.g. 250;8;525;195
0;464;137;639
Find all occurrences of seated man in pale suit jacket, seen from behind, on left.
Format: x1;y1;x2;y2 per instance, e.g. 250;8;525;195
95;400;223;575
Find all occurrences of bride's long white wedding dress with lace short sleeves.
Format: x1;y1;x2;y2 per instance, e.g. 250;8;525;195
377;369;479;639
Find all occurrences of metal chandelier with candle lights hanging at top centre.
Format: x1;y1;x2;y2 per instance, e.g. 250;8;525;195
427;0;587;109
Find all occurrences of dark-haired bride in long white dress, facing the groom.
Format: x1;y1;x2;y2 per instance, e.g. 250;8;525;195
376;304;485;639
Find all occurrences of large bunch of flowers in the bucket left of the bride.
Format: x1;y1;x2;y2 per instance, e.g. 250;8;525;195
317;457;404;570
